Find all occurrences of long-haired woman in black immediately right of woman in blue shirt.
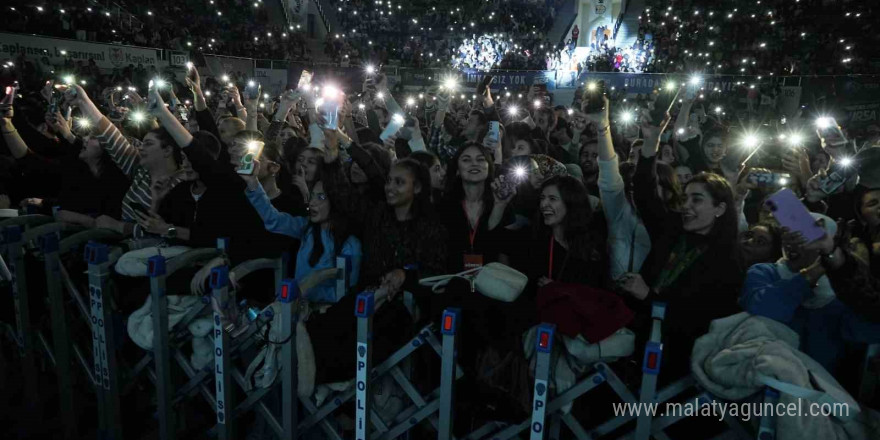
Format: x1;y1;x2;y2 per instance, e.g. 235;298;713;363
297;159;447;394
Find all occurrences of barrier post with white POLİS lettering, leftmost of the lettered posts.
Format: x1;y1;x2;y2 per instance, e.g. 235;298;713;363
85;243;122;440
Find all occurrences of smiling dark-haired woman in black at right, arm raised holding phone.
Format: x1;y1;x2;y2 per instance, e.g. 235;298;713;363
621;120;743;382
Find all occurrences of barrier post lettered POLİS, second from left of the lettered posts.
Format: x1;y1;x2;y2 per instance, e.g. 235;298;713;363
211;266;235;440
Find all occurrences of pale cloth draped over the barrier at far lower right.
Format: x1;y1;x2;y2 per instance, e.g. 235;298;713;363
691;312;880;440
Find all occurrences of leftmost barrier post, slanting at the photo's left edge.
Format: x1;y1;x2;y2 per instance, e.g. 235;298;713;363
3;226;38;409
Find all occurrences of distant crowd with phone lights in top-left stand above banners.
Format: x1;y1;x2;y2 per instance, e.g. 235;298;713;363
0;0;313;61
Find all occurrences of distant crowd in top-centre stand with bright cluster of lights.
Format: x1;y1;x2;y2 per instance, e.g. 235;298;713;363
327;0;562;70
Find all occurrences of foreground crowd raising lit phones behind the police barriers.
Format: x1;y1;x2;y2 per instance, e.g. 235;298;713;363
0;37;880;436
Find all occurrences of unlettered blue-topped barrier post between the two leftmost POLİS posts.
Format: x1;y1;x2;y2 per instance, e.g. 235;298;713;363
147;255;176;440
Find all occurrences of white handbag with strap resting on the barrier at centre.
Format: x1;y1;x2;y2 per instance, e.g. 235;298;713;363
419;263;529;302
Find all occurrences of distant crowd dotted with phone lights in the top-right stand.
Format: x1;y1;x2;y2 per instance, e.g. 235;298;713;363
639;0;880;75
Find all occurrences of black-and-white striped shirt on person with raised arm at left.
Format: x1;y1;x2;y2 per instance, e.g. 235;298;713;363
96;118;184;222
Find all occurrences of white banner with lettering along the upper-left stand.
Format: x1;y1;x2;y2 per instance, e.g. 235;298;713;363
0;33;164;69
